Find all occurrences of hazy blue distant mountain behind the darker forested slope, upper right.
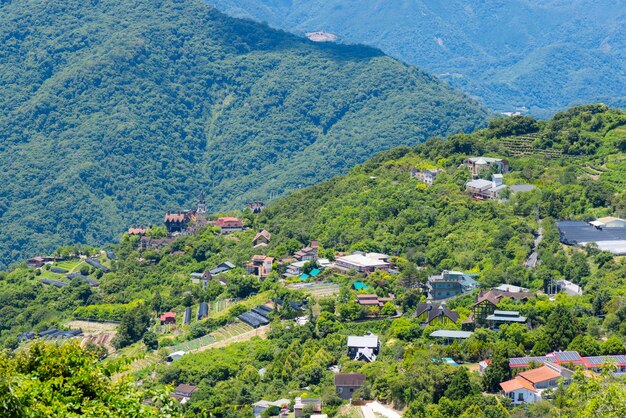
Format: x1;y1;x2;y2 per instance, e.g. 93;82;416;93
208;0;626;117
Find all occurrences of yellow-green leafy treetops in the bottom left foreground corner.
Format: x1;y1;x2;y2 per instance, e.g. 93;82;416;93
0;341;180;418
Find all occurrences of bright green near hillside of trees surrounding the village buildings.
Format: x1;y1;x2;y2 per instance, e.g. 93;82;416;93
0;105;626;418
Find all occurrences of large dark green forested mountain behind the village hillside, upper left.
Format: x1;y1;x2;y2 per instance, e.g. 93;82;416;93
0;0;486;264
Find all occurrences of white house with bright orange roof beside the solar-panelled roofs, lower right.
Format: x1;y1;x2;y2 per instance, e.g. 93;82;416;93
500;363;574;405
